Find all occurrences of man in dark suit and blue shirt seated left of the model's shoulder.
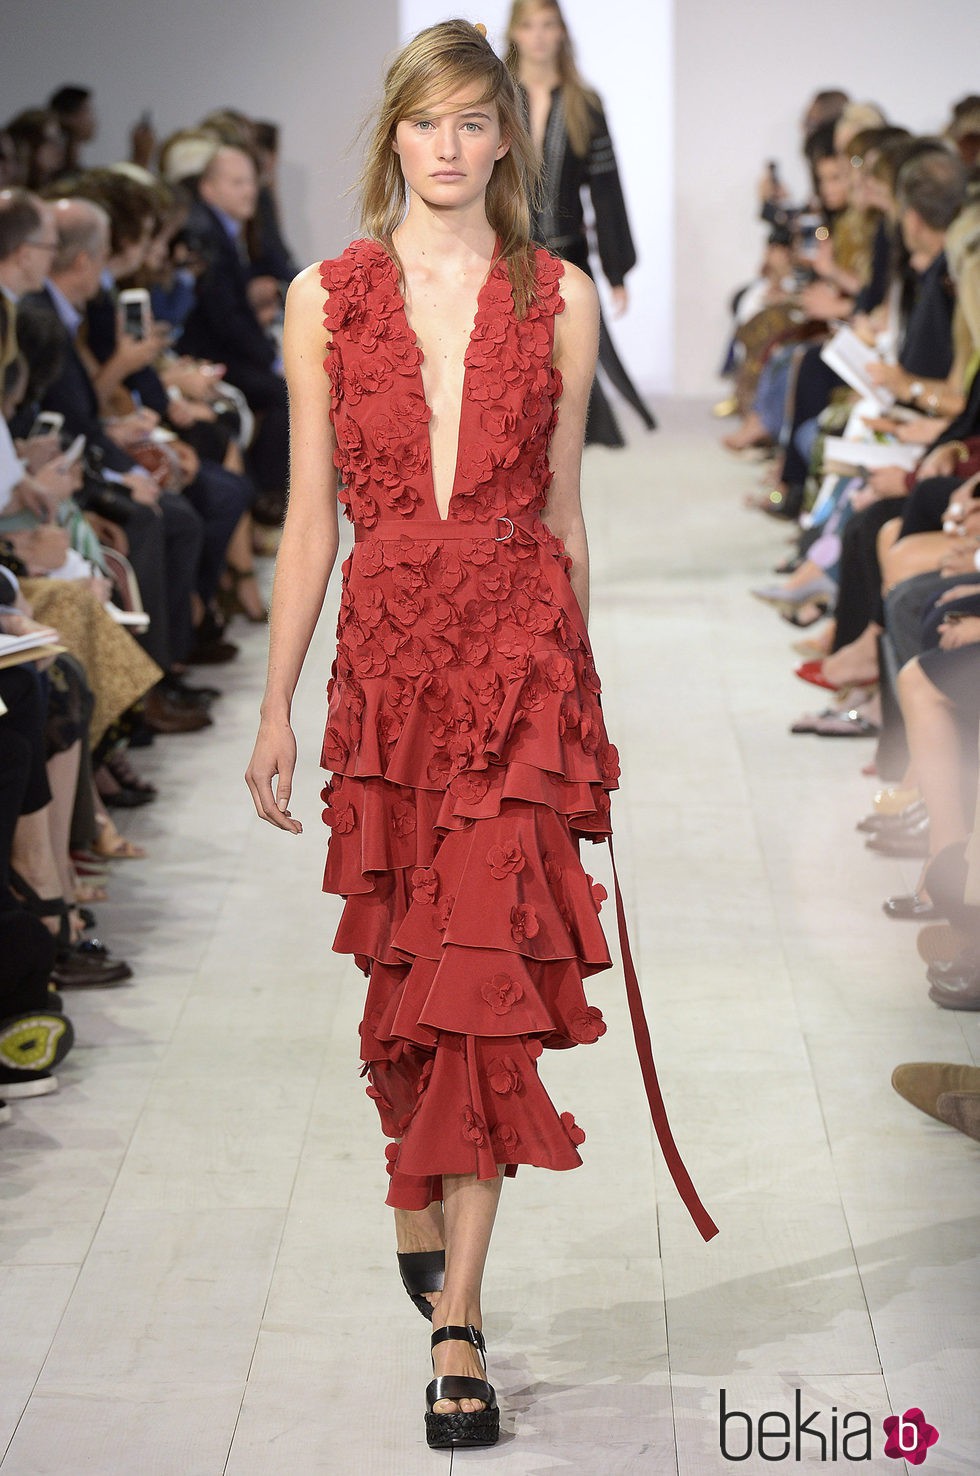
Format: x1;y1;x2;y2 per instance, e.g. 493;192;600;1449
180;145;289;521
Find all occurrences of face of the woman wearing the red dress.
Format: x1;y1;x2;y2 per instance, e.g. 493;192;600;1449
391;92;509;210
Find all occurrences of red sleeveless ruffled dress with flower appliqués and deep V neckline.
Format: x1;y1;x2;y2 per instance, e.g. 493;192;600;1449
322;241;717;1233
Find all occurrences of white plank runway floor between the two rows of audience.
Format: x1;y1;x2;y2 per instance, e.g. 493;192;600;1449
0;404;980;1476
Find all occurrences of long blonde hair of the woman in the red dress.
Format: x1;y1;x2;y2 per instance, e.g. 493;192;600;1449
360;21;539;316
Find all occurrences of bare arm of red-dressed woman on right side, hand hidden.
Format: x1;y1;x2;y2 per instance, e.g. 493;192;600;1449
542;263;599;620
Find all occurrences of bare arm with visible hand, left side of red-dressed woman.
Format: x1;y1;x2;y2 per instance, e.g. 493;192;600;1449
245;266;338;834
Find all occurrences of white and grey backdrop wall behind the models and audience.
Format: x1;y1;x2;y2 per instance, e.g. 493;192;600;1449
0;0;980;394
